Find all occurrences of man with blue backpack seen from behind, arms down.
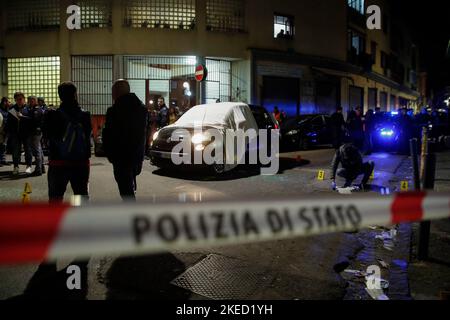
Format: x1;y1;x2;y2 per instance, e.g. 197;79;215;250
45;82;92;202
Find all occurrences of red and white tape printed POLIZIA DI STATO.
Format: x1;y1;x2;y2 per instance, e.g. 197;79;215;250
0;192;450;264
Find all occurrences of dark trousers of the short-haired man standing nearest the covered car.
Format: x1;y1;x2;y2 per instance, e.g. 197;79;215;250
113;162;142;201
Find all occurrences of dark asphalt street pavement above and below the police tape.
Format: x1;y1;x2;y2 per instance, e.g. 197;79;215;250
0;149;446;300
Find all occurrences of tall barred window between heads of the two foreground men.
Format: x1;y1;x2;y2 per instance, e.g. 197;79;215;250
72;56;113;115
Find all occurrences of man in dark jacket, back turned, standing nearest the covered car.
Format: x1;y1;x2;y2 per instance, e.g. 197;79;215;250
103;80;148;201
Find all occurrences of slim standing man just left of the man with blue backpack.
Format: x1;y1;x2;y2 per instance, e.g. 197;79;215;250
25;96;45;177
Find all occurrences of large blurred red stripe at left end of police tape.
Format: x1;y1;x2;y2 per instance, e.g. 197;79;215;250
0;204;70;264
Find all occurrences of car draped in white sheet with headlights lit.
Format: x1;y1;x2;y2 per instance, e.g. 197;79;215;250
150;102;259;174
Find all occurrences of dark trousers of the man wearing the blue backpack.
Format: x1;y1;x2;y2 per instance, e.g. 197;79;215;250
47;166;90;202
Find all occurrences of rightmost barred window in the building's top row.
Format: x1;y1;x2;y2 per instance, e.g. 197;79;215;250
206;0;245;32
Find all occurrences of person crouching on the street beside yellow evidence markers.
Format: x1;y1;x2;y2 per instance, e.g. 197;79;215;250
331;143;375;190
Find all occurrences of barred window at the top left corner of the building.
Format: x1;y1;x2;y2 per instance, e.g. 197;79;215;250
6;0;60;30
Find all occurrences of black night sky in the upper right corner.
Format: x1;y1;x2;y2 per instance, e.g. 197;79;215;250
391;0;450;92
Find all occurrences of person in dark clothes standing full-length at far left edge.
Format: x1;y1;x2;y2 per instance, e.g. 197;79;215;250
6;92;33;175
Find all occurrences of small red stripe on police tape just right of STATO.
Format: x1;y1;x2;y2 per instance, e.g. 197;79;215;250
391;192;426;224
